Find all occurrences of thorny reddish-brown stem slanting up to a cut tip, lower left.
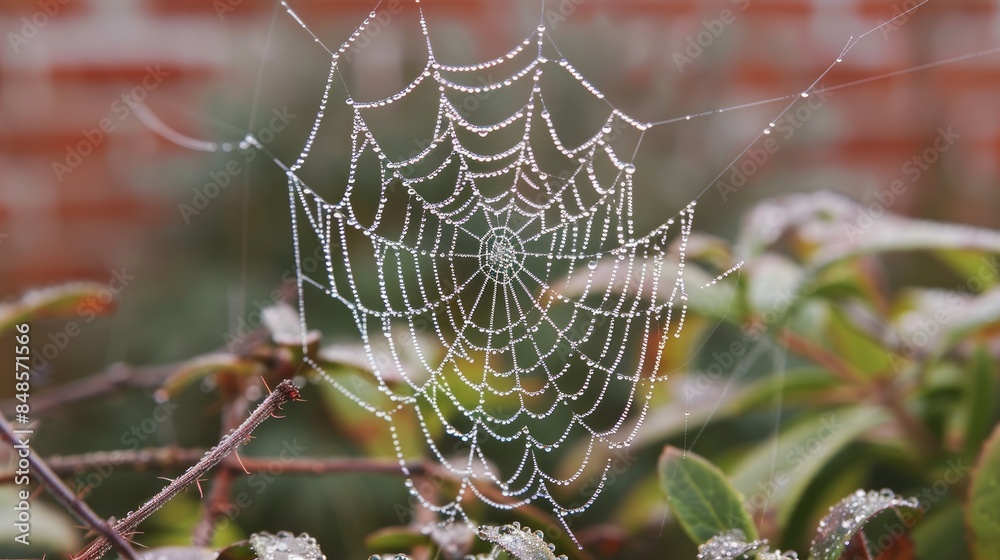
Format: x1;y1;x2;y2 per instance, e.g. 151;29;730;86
76;379;299;560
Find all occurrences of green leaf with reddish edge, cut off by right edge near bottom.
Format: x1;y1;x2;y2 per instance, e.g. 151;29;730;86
965;425;1000;560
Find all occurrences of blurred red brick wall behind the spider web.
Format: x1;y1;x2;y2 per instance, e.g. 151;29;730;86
0;0;1000;297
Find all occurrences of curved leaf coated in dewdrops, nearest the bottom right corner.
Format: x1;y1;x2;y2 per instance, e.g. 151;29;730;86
809;490;921;560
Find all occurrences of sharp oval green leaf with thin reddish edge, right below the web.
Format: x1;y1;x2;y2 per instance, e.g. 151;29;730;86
657;446;757;543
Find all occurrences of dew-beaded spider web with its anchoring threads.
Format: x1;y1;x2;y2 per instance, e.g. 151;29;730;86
270;0;926;536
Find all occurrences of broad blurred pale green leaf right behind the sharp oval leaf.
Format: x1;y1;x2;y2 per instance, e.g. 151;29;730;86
731;406;889;527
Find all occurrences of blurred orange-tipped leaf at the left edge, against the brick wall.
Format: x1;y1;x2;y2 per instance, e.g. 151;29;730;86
0;282;115;334
